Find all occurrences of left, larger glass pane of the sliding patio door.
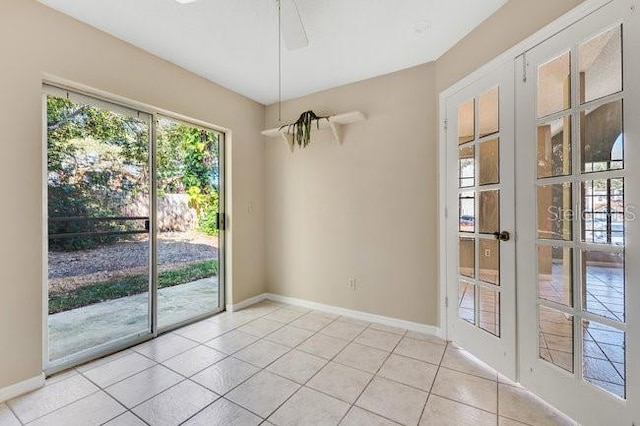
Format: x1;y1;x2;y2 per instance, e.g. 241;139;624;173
46;95;151;362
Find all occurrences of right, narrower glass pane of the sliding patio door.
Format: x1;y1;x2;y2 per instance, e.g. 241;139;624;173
156;118;221;327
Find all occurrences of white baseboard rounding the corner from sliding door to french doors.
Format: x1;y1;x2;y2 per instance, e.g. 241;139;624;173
229;293;442;337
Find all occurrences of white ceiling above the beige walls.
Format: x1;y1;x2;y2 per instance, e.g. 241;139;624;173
40;0;507;105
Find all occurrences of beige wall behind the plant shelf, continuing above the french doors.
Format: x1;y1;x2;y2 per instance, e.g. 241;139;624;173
266;0;580;325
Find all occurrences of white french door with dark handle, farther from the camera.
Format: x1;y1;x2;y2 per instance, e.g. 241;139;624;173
446;62;516;378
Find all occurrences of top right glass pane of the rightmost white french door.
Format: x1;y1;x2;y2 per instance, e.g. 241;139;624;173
579;25;622;103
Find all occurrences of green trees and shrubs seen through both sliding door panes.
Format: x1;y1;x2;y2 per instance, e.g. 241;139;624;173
47;96;219;250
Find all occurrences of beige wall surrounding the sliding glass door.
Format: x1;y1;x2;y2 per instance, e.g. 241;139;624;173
0;0;265;388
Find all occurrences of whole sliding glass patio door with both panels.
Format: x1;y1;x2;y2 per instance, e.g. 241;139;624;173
43;84;224;372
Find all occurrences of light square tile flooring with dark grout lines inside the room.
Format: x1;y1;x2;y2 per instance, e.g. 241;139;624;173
0;302;575;426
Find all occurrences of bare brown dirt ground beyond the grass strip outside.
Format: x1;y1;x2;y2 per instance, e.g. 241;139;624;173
49;231;218;290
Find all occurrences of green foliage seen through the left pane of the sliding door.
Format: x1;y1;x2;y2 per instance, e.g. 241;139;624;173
47;96;149;250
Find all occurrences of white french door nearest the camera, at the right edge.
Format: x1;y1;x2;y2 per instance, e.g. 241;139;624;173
516;0;640;426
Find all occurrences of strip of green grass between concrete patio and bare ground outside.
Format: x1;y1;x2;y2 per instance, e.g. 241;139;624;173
49;260;218;314
